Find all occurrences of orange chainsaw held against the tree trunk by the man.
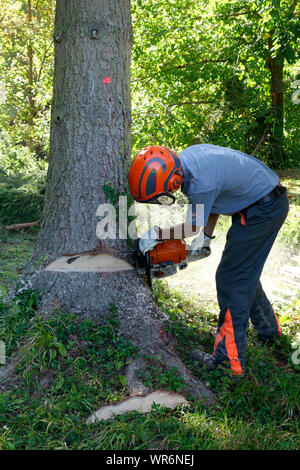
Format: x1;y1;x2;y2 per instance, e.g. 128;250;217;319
127;239;210;288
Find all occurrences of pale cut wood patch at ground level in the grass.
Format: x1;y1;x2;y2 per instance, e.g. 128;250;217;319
86;390;188;424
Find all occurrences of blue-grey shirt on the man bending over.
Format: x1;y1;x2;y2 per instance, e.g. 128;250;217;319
179;144;279;225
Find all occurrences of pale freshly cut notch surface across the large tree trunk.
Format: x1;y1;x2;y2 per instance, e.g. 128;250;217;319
45;253;134;273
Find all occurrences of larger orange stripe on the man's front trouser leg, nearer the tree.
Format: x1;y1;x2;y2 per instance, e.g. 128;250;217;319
214;309;243;375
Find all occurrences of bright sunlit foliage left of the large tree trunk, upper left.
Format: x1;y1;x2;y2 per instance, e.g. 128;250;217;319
0;0;55;157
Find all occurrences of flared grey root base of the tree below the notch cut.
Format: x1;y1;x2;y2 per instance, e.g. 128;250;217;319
8;270;215;406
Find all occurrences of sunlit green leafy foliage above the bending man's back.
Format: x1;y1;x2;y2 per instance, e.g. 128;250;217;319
132;0;300;167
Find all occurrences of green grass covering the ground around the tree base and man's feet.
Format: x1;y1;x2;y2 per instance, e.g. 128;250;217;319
0;174;300;450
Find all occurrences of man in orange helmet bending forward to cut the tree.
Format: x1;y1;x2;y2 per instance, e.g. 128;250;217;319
128;144;289;376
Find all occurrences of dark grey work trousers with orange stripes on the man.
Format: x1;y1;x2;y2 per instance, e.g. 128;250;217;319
214;193;289;375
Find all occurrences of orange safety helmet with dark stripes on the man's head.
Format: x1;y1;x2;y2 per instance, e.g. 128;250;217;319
128;145;183;204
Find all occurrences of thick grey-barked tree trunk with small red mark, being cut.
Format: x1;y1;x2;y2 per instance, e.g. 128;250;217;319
14;0;213;403
